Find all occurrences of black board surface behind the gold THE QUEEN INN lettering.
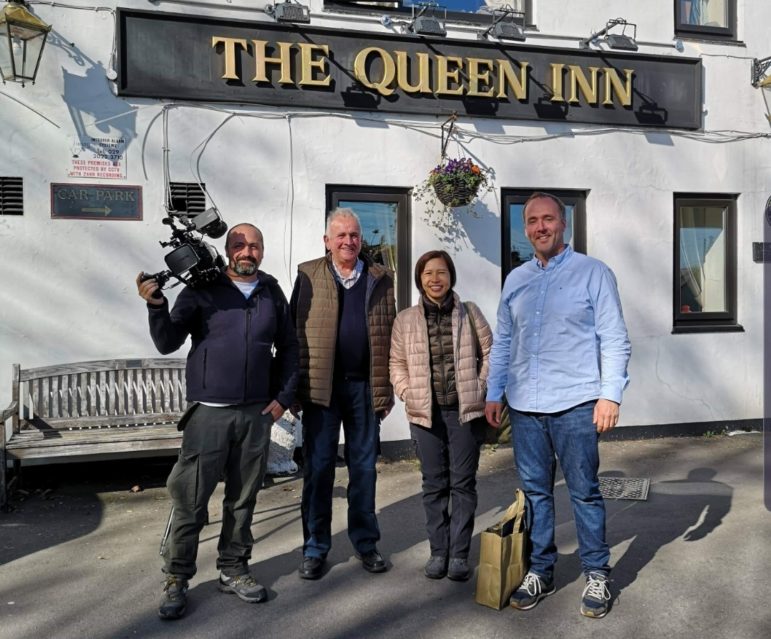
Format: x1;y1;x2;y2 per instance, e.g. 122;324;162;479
117;9;703;129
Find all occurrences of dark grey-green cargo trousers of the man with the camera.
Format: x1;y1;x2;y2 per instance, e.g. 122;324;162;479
163;403;273;579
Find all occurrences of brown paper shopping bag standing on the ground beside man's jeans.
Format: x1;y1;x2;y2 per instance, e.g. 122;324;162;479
476;489;527;610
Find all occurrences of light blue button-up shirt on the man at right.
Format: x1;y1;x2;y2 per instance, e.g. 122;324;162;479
487;246;632;413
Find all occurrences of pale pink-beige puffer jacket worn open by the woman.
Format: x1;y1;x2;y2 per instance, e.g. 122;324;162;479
390;293;493;428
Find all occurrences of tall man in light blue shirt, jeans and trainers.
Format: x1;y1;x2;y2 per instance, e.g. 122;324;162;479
485;193;631;618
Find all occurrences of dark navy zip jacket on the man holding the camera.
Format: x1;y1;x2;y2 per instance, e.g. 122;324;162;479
147;271;298;408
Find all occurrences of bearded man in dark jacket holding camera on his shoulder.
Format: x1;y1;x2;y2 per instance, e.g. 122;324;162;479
137;224;298;619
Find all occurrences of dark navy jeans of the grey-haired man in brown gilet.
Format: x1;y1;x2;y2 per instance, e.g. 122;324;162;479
302;379;380;557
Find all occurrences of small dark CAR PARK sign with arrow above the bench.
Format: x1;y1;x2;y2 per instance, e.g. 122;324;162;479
51;183;142;220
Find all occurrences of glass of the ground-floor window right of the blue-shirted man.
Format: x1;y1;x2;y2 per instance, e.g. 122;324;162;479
678;206;729;313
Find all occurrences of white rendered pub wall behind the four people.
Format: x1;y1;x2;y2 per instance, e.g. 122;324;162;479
0;0;771;440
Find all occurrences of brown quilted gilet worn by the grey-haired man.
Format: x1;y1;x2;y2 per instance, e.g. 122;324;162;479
291;256;396;412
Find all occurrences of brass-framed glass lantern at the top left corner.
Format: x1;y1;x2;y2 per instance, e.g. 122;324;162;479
0;0;51;86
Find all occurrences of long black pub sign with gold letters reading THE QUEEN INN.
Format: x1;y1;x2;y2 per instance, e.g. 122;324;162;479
118;9;702;129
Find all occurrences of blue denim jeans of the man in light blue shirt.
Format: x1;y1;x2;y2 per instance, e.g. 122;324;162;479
509;401;610;579
